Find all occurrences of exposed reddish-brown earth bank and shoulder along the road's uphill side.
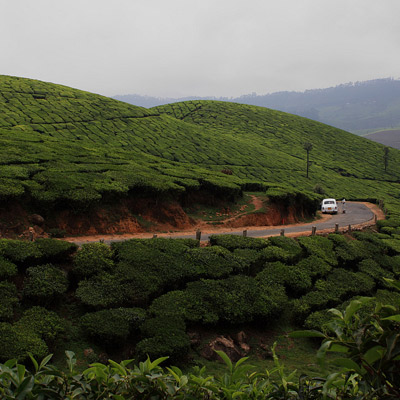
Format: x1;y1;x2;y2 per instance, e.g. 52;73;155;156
0;195;385;242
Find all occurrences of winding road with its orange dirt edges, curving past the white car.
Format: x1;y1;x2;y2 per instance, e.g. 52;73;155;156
64;202;385;245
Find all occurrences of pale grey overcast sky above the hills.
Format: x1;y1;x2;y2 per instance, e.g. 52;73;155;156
0;0;400;97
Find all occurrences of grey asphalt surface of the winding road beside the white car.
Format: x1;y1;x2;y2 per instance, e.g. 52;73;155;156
80;202;374;245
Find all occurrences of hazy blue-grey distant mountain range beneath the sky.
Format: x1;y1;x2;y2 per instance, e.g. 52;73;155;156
114;78;400;140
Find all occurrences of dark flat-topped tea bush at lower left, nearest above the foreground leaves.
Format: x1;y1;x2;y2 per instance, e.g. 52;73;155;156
80;308;146;345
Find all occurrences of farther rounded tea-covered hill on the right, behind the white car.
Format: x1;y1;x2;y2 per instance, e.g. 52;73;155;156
151;101;400;209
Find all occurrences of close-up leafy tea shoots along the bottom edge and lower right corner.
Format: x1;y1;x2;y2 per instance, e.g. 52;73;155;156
0;288;400;400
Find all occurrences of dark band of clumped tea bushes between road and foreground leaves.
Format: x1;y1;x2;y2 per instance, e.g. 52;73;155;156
0;220;400;363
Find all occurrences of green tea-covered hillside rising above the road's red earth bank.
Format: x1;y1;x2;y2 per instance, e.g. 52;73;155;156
0;76;400;230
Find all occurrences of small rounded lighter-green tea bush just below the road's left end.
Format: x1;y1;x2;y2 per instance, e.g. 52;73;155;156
73;243;114;278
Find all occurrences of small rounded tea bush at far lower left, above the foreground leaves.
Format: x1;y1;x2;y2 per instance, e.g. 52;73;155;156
14;306;65;342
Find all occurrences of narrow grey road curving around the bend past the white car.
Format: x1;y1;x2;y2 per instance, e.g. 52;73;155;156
70;202;376;245
